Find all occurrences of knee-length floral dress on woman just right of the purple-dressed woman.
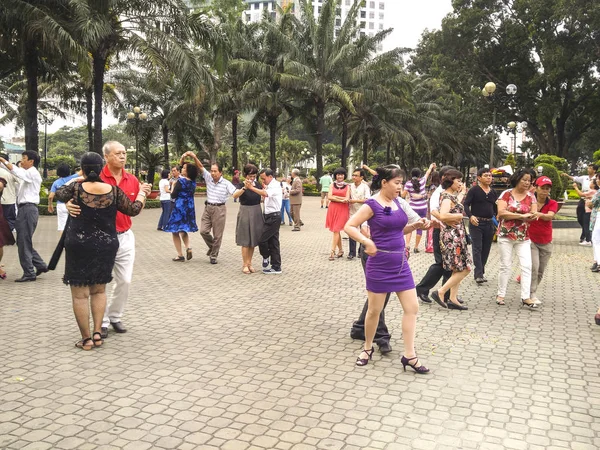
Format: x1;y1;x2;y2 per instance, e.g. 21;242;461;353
440;192;473;272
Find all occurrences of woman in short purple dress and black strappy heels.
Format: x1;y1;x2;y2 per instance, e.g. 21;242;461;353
344;165;429;374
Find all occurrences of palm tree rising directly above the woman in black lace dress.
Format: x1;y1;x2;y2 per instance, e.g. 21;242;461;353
72;0;212;152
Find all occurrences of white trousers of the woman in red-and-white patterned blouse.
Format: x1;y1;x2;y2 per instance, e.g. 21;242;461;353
498;237;531;300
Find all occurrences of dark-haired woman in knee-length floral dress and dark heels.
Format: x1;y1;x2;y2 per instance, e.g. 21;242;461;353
431;169;473;311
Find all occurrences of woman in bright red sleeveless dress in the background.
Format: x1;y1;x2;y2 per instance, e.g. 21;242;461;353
325;167;350;261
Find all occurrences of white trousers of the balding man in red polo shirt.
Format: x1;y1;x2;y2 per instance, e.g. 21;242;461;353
102;230;135;327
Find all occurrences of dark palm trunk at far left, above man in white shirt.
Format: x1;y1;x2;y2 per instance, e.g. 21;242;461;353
23;37;39;152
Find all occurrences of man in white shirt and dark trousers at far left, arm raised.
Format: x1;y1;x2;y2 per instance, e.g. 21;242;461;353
0;150;48;283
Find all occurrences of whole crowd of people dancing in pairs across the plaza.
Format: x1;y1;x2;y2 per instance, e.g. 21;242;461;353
0;141;600;362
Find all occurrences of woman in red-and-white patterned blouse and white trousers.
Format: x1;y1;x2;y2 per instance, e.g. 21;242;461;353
496;169;538;309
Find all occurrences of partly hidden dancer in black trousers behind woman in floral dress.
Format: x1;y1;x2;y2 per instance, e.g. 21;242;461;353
416;166;462;303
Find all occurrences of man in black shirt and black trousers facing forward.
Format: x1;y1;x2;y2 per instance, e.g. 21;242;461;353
464;168;498;284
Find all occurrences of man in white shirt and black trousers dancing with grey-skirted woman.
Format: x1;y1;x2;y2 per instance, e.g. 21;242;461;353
244;169;283;275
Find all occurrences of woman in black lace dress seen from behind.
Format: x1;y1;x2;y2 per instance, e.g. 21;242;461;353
56;153;146;350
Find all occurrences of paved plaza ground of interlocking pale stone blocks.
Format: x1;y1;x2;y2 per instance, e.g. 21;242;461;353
0;198;600;450
